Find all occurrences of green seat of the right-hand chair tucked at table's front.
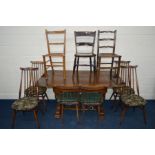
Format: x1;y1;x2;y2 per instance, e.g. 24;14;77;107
80;92;103;105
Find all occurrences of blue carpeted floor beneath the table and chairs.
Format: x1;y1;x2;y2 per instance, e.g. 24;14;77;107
0;100;155;129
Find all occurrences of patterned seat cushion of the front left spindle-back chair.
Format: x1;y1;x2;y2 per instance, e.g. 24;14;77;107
11;97;38;111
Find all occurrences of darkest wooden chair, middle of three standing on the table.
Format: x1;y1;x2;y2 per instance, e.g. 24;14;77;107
73;31;96;74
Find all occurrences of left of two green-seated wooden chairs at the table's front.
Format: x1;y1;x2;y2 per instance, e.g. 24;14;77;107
53;86;80;120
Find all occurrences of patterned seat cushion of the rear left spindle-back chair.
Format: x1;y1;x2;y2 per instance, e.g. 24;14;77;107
25;86;47;96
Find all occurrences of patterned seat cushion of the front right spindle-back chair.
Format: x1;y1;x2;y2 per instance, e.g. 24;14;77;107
121;94;146;106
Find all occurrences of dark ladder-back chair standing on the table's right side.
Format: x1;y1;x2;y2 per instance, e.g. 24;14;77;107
97;30;121;80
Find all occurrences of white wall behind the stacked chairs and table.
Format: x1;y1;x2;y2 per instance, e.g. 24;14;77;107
0;26;155;99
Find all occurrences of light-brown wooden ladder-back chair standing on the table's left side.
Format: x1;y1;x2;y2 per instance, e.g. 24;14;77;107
43;30;66;79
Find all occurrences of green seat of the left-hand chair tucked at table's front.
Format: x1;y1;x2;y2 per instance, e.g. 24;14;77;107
56;92;80;104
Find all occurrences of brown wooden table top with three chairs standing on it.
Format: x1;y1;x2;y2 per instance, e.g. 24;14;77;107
39;70;115;88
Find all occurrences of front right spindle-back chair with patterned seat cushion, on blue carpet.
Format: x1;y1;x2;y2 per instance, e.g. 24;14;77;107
120;65;147;125
